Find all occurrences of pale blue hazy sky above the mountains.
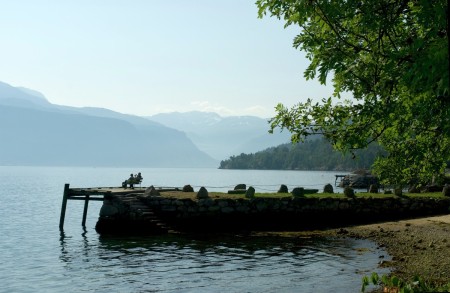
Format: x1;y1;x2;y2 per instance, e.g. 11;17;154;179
0;0;332;118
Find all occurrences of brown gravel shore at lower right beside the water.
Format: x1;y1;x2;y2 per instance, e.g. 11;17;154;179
332;215;450;284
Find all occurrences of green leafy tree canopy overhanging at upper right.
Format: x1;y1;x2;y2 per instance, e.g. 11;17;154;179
256;0;450;184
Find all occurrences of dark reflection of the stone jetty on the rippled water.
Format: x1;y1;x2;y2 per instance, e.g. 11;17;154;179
95;234;366;258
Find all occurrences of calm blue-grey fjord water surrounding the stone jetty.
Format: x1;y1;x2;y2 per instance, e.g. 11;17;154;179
0;167;386;292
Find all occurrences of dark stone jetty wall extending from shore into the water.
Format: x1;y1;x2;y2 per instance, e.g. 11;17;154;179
96;189;450;234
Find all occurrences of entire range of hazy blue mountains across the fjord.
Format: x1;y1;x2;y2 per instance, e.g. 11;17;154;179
0;82;288;167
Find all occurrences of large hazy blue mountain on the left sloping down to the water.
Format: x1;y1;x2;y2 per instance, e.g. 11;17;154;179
0;82;218;167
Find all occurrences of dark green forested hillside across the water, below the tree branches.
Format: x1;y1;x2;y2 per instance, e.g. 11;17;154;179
219;139;384;171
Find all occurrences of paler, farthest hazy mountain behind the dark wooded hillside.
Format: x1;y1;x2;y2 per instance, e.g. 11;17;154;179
147;111;290;160
